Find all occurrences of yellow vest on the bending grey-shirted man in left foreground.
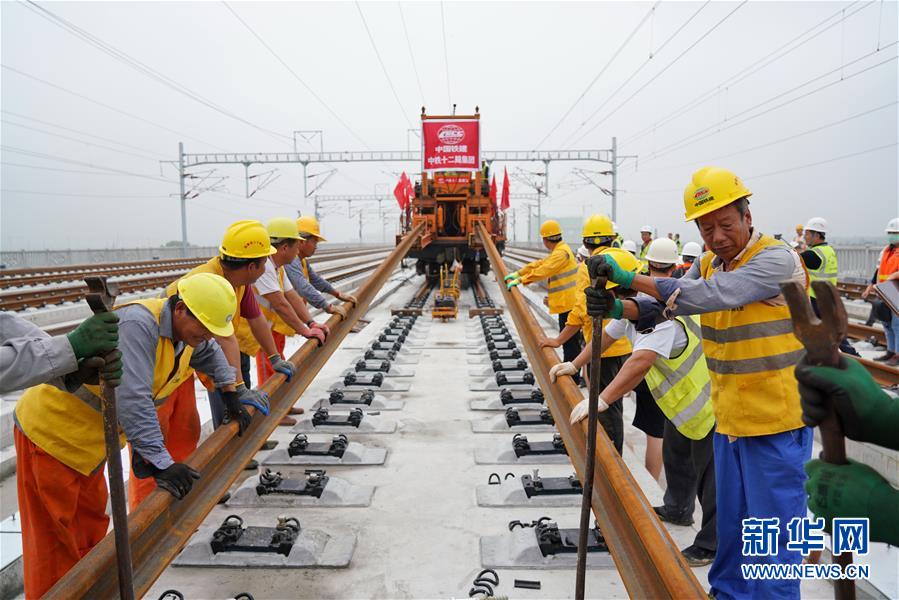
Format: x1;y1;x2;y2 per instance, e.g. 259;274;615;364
15;298;194;475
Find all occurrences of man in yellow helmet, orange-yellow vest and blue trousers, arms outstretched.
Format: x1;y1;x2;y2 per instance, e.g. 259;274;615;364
586;167;812;599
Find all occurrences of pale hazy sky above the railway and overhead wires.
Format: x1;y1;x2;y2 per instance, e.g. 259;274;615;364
0;1;899;249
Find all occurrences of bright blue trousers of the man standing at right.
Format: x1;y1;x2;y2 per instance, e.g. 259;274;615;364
709;427;813;600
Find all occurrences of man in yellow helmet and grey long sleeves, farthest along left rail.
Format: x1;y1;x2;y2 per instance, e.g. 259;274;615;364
284;216;356;318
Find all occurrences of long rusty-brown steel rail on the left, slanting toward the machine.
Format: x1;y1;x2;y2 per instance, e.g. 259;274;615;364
44;225;423;600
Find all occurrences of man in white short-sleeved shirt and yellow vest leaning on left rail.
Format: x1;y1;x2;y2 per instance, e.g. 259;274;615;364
243;217;325;382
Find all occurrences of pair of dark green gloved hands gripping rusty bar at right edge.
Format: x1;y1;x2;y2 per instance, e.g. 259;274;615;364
796;357;899;546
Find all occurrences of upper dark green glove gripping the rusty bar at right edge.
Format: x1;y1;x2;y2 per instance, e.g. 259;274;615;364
796;357;899;449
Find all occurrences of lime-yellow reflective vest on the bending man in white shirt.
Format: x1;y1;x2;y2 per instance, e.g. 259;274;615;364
646;316;715;440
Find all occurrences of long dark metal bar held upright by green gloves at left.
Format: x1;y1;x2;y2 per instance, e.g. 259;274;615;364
84;277;134;600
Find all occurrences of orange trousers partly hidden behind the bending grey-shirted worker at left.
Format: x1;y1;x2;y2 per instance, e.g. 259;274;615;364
128;377;200;511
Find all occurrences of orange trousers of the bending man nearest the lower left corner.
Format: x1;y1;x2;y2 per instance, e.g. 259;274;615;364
13;425;109;600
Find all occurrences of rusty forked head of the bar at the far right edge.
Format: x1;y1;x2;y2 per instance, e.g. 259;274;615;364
780;281;849;366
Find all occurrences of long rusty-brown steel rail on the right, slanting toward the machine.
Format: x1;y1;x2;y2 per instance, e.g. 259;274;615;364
478;224;708;599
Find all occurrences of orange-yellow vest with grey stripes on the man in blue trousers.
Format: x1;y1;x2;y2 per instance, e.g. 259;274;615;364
700;235;808;437
